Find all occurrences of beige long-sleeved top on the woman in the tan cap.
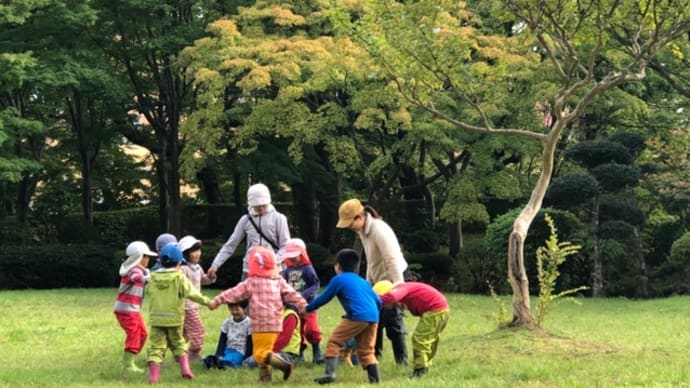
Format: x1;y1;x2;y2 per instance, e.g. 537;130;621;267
358;213;407;284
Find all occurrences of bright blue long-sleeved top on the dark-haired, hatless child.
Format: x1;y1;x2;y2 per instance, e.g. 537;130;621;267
307;272;383;323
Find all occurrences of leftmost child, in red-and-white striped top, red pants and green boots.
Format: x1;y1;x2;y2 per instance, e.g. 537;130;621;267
114;241;158;373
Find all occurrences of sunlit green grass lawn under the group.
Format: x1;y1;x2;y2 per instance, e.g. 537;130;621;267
0;289;690;387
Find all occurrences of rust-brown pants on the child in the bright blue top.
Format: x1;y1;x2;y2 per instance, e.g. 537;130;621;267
325;318;378;368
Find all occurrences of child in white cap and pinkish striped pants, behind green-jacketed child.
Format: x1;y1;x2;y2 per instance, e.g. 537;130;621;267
177;236;215;361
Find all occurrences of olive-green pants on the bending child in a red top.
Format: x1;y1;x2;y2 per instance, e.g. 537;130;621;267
412;309;449;369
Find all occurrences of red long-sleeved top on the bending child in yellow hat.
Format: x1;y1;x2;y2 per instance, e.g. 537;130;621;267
381;282;448;317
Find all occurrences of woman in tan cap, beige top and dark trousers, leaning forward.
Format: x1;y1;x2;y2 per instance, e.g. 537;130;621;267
336;198;409;365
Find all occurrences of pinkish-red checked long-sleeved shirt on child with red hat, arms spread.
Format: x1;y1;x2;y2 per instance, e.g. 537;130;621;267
213;275;307;333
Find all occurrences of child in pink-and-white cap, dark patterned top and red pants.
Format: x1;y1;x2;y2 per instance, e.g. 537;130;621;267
282;238;323;364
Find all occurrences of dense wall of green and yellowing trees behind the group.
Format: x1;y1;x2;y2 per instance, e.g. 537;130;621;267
0;0;690;312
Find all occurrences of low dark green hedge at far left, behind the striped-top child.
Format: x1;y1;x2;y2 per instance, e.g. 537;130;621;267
0;244;118;289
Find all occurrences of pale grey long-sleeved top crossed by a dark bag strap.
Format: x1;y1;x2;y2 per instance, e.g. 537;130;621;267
211;205;290;272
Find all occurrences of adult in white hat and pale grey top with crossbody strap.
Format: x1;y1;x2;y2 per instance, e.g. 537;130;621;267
207;183;290;280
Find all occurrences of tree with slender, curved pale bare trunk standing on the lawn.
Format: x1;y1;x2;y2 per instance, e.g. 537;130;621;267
336;0;690;327
